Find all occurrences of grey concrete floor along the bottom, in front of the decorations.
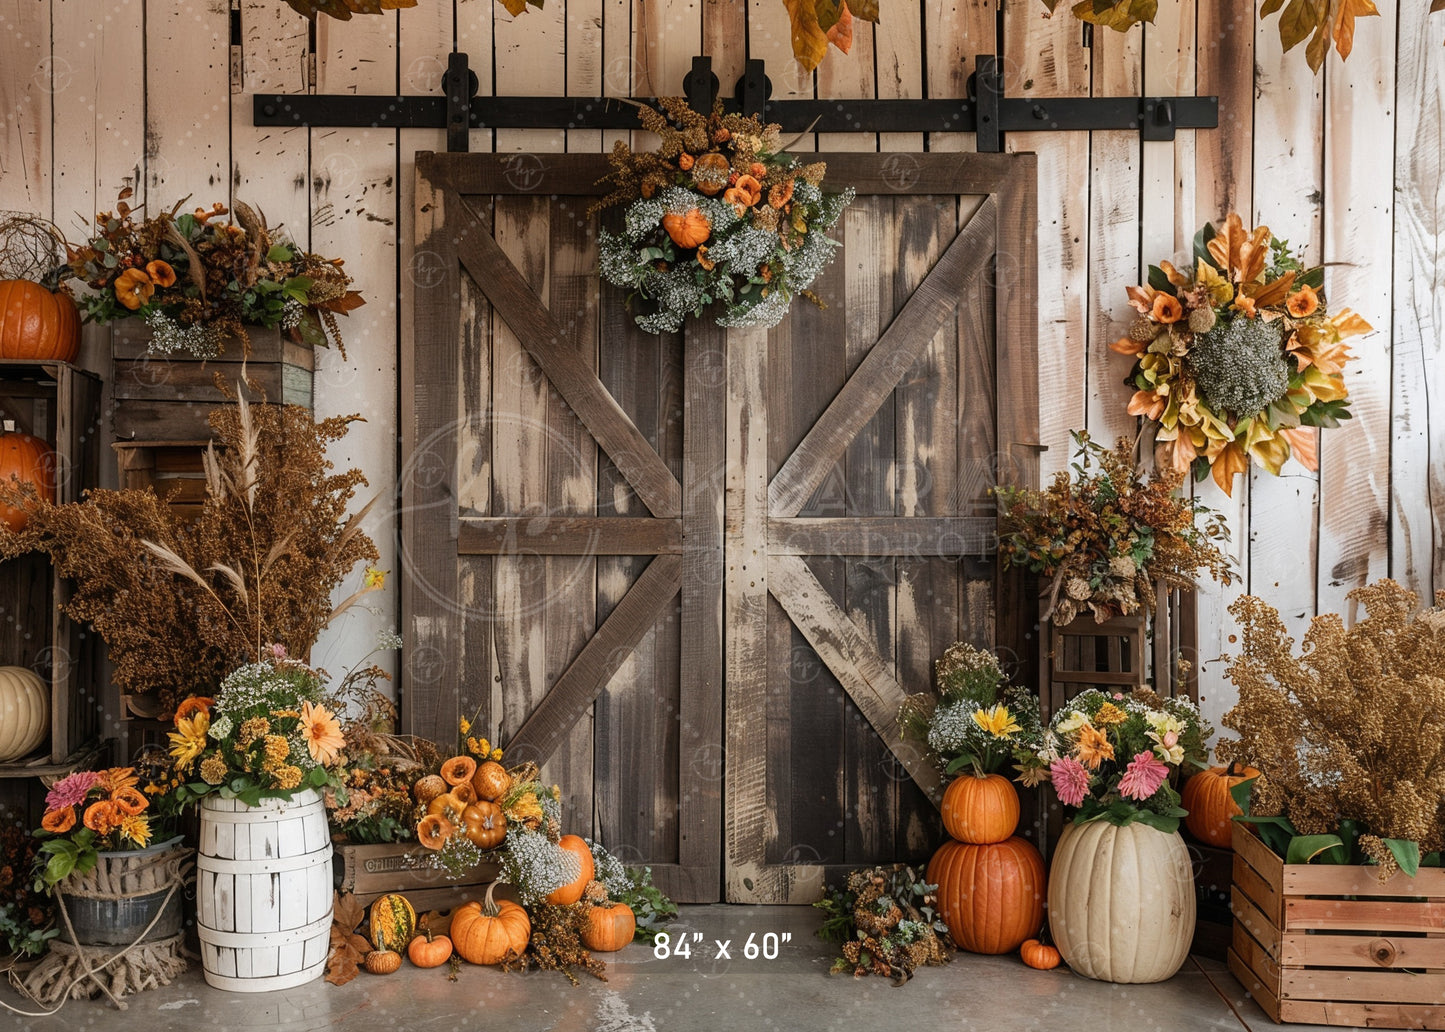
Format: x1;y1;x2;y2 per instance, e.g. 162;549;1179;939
0;905;1329;1032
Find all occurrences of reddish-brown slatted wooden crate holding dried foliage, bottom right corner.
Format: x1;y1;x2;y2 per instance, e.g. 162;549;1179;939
1230;824;1445;1029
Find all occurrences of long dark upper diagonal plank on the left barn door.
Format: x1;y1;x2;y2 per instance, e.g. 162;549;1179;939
447;187;682;517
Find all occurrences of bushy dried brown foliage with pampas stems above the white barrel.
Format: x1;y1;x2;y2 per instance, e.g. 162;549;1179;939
0;399;377;708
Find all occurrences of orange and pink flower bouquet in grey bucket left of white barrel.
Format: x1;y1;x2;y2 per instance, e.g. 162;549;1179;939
35;767;172;892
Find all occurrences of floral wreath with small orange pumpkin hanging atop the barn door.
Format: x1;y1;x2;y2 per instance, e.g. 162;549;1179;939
594;98;854;334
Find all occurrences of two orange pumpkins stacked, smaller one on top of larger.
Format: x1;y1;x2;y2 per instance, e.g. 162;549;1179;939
926;773;1045;954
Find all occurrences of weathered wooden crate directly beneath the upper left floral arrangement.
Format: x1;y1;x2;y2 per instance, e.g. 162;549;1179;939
110;319;316;442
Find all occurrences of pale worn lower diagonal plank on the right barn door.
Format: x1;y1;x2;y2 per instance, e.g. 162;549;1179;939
767;555;942;805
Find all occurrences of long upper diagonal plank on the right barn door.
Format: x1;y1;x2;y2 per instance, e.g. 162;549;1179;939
767;197;997;516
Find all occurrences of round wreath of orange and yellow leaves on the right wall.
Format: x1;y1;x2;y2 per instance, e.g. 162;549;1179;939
1110;214;1373;494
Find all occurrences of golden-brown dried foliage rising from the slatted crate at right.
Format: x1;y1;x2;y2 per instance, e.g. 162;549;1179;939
1218;580;1445;859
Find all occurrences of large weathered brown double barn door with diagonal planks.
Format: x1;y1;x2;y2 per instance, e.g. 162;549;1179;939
402;155;1038;902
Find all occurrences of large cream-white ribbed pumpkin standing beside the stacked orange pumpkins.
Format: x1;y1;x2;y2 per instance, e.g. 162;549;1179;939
1049;821;1195;983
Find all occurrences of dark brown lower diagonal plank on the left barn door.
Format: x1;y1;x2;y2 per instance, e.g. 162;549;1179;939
506;555;682;765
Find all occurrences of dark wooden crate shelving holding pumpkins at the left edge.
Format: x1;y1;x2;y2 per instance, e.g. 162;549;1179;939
0;360;103;778
